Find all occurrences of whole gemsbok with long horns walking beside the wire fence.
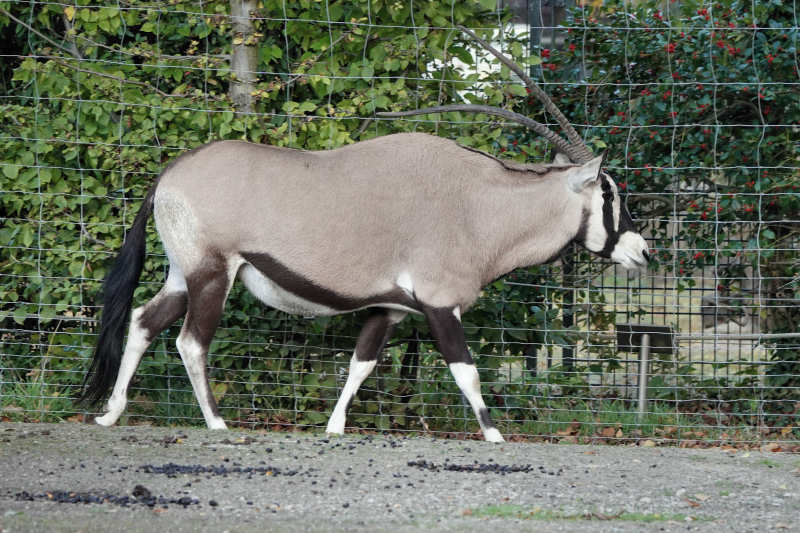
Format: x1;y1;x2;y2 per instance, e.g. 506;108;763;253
82;28;649;442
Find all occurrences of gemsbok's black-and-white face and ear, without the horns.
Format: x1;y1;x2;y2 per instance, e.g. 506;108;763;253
556;154;650;269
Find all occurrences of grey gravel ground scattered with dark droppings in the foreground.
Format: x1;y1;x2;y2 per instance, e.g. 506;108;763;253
0;423;800;533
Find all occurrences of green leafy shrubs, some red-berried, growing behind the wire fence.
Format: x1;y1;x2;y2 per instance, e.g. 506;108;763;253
0;0;800;431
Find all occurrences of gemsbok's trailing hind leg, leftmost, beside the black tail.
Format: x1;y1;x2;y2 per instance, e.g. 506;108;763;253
95;266;186;426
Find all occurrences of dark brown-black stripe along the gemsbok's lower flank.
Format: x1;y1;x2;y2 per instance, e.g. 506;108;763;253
242;252;419;312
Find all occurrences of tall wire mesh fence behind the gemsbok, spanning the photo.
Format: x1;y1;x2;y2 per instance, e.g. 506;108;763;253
0;0;800;445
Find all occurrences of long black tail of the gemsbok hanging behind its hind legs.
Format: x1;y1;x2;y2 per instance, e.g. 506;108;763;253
79;186;156;405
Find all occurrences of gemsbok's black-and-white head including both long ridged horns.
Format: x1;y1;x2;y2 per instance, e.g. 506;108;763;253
378;26;650;268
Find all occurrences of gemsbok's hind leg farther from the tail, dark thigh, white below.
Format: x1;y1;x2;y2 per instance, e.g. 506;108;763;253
177;260;235;429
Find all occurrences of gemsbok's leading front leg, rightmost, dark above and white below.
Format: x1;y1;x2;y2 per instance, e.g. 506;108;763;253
424;307;504;442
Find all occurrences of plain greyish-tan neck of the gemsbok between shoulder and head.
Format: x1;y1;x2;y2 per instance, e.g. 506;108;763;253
480;176;583;282
